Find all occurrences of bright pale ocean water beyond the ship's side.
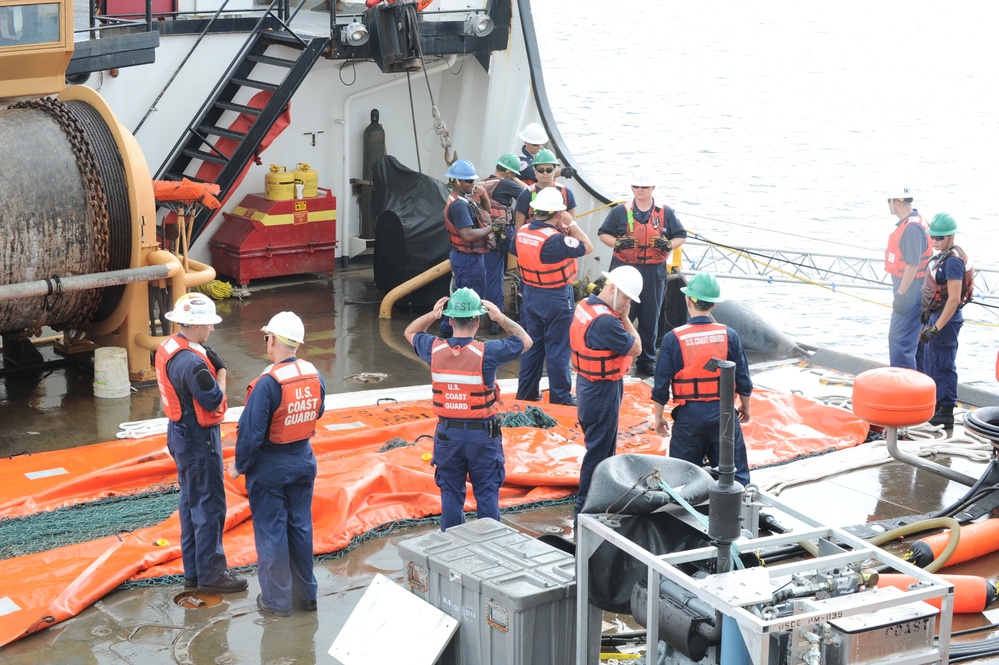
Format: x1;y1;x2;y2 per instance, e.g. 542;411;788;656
533;0;999;386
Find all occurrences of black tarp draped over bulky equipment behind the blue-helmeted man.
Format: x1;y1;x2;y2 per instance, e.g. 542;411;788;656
371;155;451;311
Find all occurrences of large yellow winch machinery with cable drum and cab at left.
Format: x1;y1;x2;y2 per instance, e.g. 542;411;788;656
0;0;215;381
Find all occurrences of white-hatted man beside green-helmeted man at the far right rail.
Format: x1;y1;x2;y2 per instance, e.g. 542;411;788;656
885;187;932;369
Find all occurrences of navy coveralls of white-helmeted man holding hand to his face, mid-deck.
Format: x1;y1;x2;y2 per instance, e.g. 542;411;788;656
573;295;635;515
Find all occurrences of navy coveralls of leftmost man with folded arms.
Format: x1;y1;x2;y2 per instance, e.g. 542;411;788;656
167;342;227;586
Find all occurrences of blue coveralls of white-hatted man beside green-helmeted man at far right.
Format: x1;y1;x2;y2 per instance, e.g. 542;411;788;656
888;209;929;370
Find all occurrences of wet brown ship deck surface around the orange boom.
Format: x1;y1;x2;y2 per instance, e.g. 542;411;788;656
0;261;999;665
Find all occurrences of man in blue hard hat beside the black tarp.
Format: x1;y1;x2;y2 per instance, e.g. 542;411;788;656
441;159;496;336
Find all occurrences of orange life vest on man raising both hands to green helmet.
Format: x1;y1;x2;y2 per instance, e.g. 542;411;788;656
430;339;499;420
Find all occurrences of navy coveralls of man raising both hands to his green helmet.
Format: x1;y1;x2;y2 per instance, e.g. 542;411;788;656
413;332;524;531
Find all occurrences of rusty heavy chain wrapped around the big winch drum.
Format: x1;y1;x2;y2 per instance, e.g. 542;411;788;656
8;98;110;341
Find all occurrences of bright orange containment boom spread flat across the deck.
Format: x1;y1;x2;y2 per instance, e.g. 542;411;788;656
0;381;868;646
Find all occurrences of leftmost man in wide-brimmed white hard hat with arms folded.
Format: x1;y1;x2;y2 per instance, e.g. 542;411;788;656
156;293;246;593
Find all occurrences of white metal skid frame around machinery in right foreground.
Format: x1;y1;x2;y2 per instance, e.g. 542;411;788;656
576;491;954;665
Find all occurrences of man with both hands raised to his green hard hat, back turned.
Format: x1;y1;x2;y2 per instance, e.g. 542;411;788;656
405;289;531;531
